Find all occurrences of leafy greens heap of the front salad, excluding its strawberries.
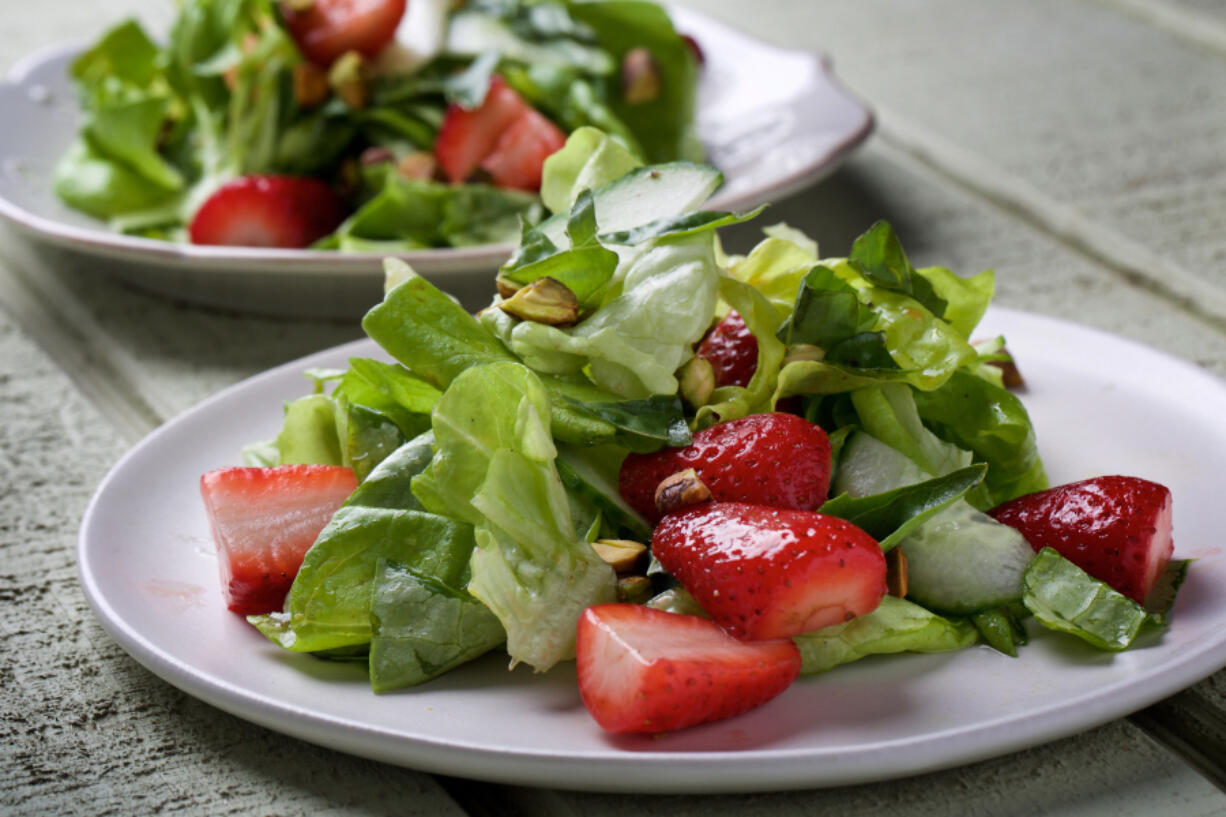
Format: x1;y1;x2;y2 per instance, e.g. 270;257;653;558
215;128;1183;692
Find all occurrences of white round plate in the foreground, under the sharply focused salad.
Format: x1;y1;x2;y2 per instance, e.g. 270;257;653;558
80;309;1226;792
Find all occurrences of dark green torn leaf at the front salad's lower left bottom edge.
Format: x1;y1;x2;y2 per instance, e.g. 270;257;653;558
370;559;506;692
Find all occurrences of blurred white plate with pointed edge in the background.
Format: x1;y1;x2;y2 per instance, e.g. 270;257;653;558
0;7;873;318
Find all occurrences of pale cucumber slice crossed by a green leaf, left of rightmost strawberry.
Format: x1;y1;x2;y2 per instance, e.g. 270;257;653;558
834;432;1035;613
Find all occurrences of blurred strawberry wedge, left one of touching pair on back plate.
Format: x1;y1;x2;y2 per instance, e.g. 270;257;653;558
434;75;531;182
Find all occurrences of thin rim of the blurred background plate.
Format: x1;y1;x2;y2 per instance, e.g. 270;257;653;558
0;4;877;277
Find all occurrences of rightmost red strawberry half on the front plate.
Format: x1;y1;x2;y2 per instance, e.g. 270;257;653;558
988;476;1175;604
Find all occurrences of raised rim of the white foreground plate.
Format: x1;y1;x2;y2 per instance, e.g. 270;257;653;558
77;307;1226;792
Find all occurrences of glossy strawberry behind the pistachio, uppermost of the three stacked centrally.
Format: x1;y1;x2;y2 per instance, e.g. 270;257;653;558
618;413;830;521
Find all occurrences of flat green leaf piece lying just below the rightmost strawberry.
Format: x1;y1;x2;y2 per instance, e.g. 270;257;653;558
1022;547;1150;651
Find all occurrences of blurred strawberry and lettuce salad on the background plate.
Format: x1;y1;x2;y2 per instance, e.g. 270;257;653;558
54;0;702;247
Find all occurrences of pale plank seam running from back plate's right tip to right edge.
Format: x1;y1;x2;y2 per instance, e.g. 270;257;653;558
877;105;1226;332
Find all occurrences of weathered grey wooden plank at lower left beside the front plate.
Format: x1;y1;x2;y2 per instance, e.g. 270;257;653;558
0;299;462;817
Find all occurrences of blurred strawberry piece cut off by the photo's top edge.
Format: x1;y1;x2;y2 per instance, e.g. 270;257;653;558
281;0;407;66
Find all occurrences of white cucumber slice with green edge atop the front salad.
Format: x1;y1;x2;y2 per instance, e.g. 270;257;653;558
537;162;723;249
